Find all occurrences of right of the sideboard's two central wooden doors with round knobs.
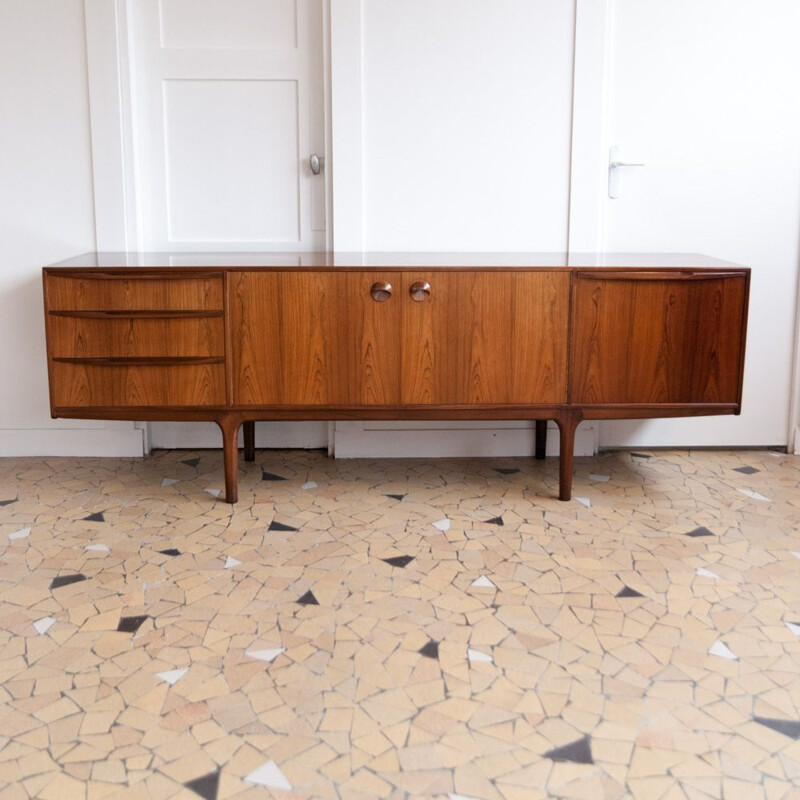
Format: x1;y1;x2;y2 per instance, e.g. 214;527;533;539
401;270;569;405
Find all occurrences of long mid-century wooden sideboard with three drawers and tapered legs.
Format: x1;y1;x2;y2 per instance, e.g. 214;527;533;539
43;252;750;503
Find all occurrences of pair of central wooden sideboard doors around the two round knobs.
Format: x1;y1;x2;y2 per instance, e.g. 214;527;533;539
230;271;569;405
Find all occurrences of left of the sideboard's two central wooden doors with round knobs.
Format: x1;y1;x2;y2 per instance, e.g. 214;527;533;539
230;271;401;406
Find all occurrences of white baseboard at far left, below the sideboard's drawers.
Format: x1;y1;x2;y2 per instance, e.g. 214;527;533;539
0;422;144;458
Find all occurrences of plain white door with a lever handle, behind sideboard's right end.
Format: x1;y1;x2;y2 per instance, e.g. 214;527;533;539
600;0;800;447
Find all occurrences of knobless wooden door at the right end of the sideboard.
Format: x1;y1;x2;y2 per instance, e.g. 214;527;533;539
572;270;747;405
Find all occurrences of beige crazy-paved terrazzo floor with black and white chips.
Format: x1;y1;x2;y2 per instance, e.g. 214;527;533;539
0;450;800;800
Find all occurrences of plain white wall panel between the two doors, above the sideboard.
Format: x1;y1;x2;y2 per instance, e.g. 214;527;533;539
360;0;574;251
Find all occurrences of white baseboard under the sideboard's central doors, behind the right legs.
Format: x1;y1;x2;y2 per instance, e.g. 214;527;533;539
333;421;596;458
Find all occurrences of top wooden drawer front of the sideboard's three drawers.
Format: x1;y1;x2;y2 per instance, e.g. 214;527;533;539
45;274;222;311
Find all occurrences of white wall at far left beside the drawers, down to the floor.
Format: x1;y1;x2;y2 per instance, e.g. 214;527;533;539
0;0;142;455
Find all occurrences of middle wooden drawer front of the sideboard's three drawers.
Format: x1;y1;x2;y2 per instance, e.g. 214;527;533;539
49;315;225;357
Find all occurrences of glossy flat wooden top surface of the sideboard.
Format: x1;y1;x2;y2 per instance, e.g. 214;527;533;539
45;252;746;271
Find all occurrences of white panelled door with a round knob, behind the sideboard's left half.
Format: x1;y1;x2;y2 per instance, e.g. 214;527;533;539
130;0;330;447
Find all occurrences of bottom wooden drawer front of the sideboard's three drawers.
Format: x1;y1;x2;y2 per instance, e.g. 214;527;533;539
52;361;225;416
